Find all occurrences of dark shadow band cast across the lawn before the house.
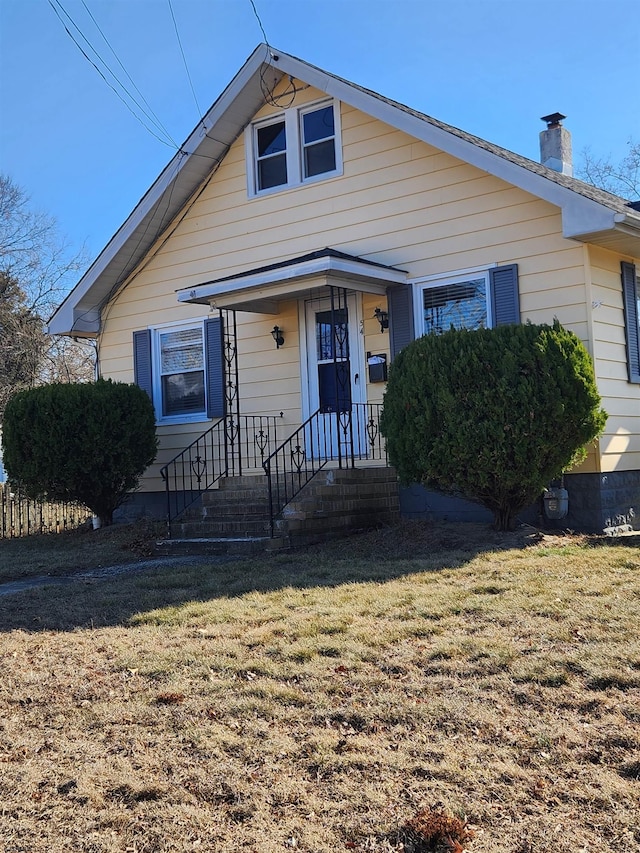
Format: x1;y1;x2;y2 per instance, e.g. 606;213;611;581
0;522;632;632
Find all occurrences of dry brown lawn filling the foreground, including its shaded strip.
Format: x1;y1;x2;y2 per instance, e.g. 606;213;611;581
0;526;640;853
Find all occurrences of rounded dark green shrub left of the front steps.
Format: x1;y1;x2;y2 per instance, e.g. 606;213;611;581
2;379;157;524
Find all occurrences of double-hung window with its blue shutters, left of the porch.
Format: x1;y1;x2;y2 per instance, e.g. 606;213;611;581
133;318;224;423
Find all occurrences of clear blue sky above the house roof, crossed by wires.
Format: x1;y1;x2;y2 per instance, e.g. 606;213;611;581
0;0;640;262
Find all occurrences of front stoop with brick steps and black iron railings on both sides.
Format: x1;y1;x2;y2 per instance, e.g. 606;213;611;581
160;404;399;553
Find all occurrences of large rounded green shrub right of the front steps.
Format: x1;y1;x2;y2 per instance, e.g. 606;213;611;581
381;321;607;530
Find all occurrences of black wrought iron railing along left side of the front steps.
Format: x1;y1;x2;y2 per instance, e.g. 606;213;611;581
160;413;282;536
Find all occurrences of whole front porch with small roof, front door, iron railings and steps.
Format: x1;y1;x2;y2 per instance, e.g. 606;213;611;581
151;249;406;542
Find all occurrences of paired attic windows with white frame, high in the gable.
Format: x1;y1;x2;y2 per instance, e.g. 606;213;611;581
245;101;342;196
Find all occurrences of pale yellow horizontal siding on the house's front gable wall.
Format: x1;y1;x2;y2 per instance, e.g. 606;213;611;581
100;89;612;488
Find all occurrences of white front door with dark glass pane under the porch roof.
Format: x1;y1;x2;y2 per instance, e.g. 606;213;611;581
305;290;366;459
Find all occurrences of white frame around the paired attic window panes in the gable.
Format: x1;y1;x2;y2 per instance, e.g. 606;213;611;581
245;99;343;198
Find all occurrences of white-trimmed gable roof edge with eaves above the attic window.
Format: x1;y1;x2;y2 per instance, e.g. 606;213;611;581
49;44;640;336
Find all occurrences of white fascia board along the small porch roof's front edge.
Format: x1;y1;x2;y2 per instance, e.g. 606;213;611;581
177;257;407;304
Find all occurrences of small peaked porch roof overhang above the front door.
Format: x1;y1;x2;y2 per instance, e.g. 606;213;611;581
177;249;408;314
